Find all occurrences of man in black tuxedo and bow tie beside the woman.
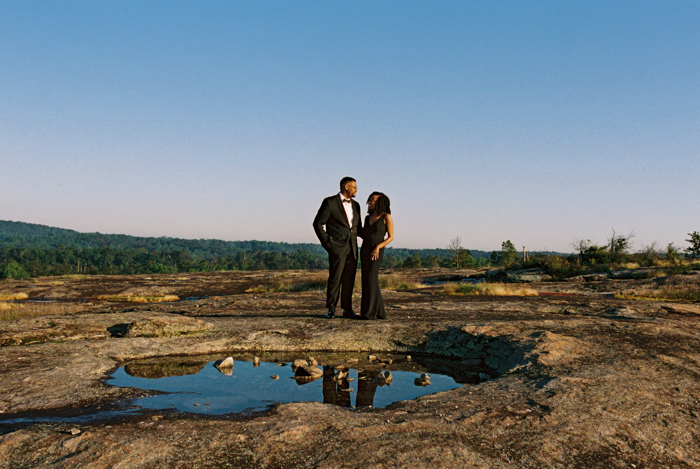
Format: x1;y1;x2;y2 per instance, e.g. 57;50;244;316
314;177;362;319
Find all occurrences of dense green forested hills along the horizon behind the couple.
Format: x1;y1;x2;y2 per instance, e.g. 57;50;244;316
0;220;491;278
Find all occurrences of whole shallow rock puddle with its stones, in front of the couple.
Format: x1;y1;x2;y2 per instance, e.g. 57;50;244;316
107;353;490;415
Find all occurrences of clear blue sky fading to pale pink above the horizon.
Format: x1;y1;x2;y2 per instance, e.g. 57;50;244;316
0;0;700;251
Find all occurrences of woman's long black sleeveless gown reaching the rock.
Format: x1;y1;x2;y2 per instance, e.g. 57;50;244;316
360;215;386;319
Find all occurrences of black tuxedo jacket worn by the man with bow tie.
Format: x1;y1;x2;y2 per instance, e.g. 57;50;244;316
314;194;362;259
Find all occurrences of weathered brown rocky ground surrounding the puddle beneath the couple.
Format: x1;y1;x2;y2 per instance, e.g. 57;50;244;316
0;270;700;469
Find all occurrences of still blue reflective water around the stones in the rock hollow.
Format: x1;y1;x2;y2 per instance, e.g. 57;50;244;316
107;354;470;415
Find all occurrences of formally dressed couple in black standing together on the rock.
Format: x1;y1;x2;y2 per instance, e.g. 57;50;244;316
314;177;394;319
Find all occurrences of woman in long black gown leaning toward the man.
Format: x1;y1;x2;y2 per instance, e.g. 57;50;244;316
360;192;394;319
